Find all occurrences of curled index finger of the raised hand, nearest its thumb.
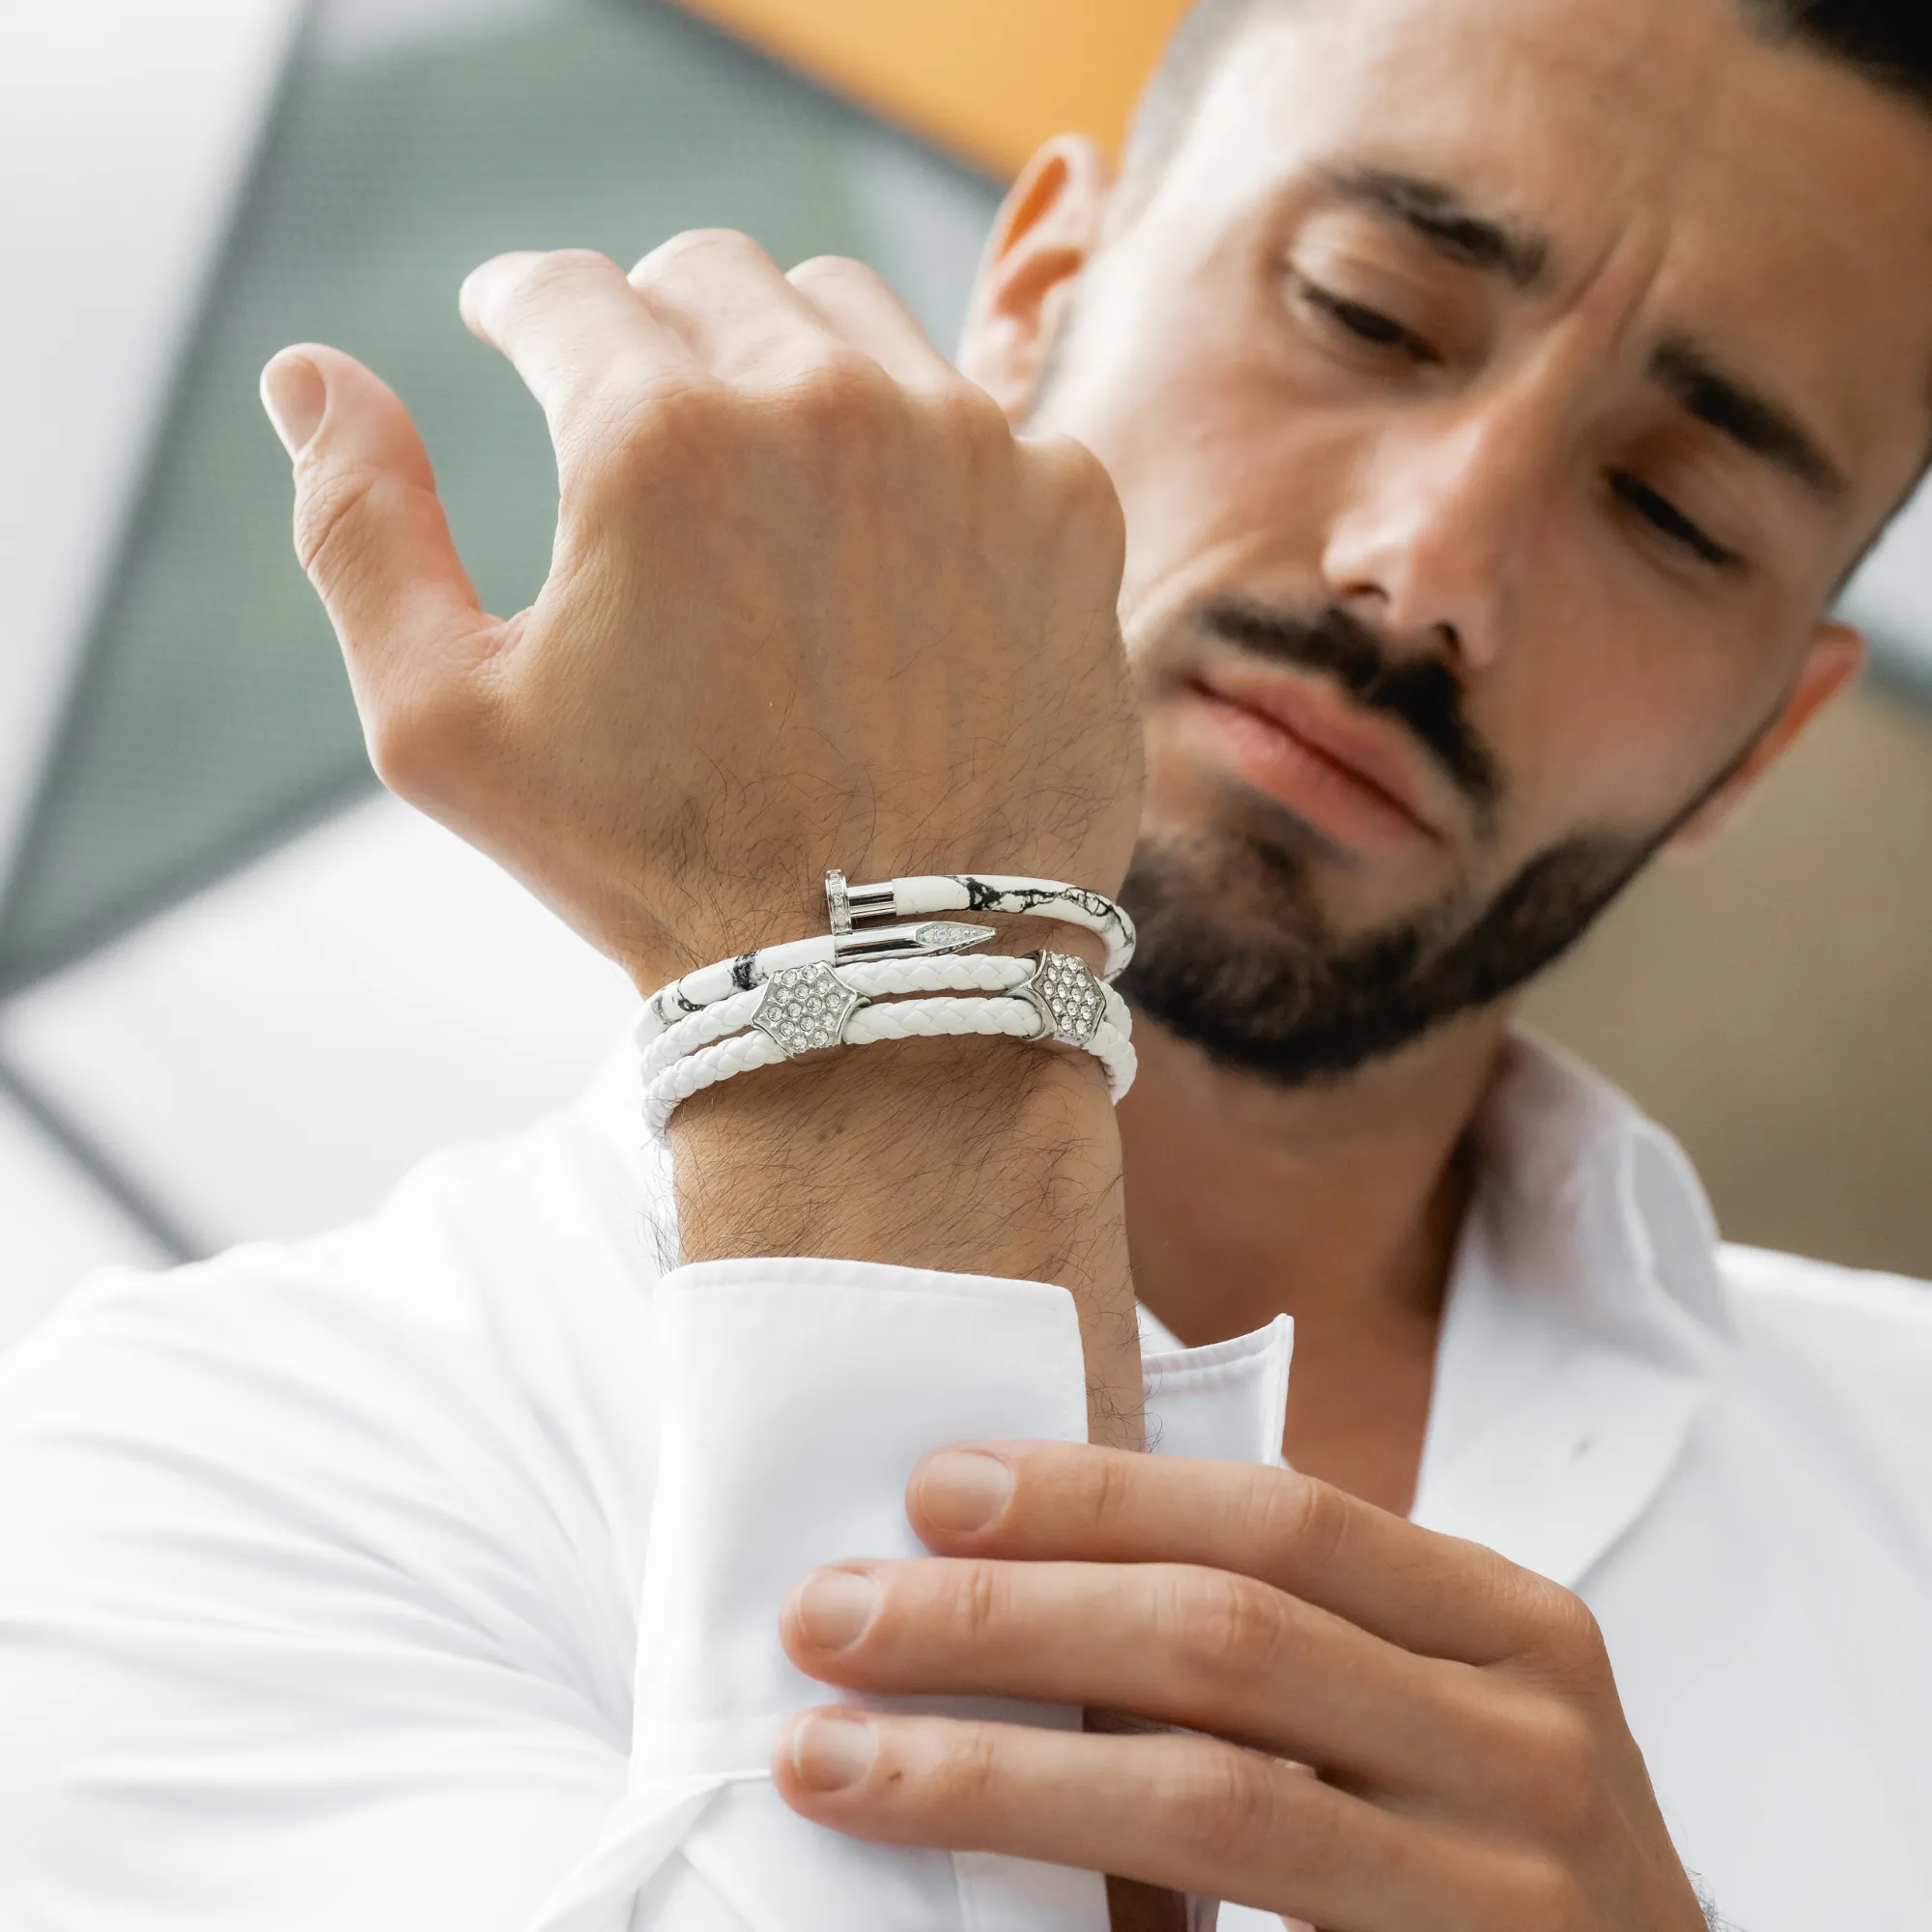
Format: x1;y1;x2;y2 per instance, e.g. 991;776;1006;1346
458;249;701;444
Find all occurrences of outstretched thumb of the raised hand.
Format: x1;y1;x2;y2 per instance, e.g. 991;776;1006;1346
261;344;500;719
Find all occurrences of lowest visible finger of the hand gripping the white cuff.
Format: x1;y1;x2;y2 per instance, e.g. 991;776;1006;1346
771;1708;1528;1932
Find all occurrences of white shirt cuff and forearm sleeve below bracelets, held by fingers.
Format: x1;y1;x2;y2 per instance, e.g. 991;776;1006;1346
537;1260;1107;1932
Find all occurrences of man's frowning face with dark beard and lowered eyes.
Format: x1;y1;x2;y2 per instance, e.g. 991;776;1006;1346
1005;0;1932;1080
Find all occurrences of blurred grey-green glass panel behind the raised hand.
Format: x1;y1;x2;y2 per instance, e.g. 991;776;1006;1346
0;0;993;989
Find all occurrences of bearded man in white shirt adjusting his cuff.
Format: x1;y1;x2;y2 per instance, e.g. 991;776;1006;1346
0;0;1932;1932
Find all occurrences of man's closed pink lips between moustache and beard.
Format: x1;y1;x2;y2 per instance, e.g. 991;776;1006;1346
1190;667;1447;854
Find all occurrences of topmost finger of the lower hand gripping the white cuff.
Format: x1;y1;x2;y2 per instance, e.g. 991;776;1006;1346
906;1443;1588;1663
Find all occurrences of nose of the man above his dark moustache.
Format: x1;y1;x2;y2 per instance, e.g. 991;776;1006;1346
1321;394;1555;670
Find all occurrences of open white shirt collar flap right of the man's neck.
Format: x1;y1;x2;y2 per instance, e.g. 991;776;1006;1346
1412;1036;1731;1584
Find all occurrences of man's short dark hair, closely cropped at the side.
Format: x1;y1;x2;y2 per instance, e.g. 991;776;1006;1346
1126;0;1932;184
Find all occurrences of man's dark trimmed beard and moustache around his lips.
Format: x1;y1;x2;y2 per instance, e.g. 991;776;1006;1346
1121;599;1723;1086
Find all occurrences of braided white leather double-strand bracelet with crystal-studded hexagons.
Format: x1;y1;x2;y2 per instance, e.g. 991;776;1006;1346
643;952;1134;1134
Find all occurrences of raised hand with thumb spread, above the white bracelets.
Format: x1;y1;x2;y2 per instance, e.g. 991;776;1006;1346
263;234;1140;983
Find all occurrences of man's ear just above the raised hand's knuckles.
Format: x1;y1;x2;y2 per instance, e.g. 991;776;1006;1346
960;133;1113;423
